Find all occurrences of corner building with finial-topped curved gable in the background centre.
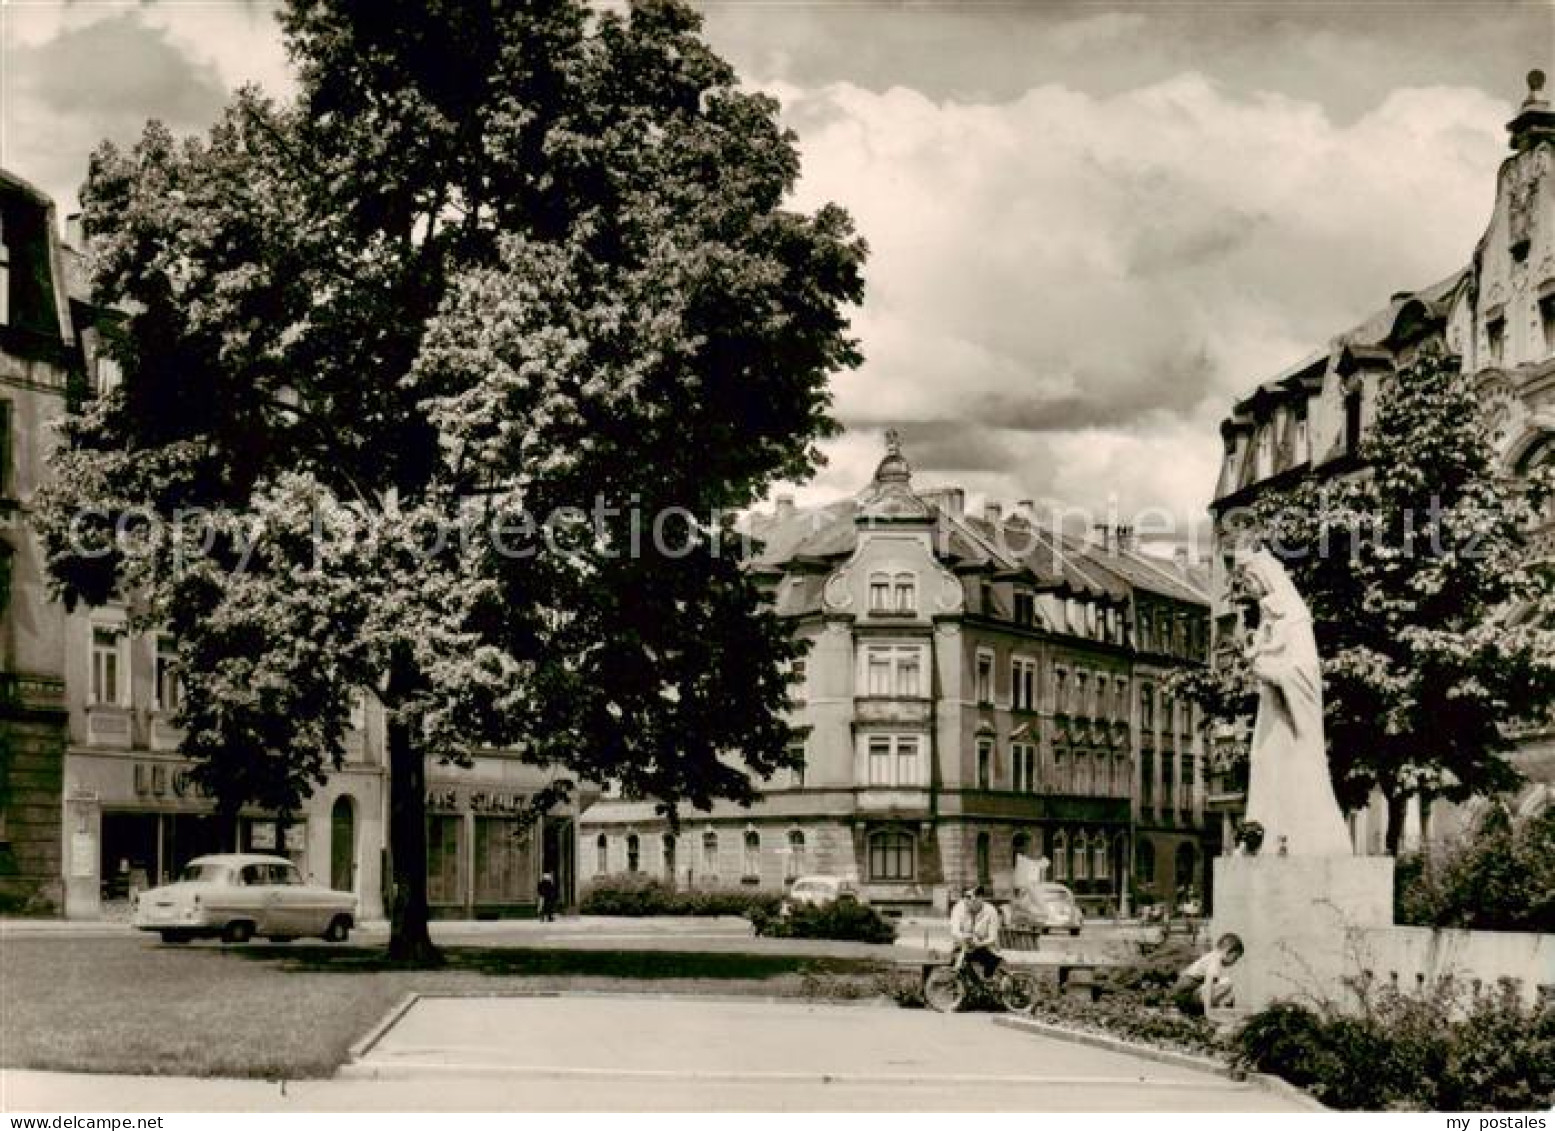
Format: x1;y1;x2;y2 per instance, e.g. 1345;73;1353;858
580;437;1208;909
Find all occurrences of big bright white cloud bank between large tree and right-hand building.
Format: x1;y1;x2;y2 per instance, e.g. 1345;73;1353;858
774;73;1510;515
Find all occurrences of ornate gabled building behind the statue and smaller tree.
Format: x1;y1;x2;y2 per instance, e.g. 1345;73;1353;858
1210;72;1555;853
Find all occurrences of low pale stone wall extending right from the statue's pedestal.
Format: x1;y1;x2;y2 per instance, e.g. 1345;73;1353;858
1350;927;1555;1003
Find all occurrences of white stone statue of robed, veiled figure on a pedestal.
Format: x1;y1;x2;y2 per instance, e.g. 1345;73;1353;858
1239;551;1353;856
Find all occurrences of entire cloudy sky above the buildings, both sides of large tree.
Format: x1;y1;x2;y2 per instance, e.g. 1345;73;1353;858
0;0;1555;544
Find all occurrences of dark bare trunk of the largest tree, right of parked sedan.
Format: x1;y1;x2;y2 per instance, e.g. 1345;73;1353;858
389;714;443;966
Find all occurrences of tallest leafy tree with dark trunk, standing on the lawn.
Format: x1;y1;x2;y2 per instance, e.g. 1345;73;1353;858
40;0;865;960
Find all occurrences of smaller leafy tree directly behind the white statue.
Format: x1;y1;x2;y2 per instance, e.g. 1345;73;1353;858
1183;353;1555;851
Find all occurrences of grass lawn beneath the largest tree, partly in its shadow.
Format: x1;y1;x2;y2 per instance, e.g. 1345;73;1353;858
0;935;894;1078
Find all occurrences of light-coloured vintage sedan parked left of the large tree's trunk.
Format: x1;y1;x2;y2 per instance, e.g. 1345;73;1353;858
134;853;356;943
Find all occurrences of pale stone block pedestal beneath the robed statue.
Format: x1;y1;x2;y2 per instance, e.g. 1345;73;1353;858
1210;856;1393;1013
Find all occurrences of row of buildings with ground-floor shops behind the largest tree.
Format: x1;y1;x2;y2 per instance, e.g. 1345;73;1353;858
0;174;577;919
